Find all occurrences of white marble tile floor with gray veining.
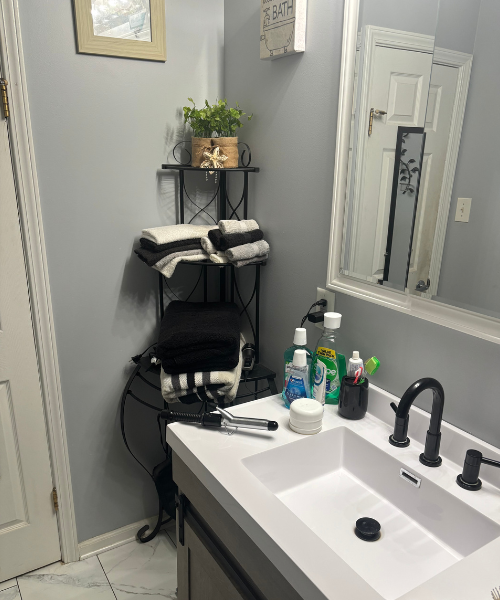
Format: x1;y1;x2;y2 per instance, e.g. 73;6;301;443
0;527;177;600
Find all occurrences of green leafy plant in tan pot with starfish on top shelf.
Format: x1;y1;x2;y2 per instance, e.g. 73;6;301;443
183;98;253;169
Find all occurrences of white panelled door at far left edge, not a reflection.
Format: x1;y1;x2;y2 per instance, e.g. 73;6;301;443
0;91;61;582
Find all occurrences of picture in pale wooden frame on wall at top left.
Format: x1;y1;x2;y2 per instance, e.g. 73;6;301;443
74;0;167;62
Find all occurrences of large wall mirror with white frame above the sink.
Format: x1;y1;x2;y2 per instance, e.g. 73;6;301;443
327;0;500;342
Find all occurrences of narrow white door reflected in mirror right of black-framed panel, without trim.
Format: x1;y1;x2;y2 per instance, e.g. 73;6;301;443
407;64;458;291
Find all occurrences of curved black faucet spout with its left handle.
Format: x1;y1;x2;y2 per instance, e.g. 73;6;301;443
389;377;444;467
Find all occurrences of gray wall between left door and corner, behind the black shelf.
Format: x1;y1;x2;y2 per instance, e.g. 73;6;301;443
19;0;223;541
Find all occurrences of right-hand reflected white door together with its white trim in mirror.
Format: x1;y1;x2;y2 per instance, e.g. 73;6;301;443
408;48;472;298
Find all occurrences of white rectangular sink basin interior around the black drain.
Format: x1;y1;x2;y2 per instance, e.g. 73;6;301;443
243;427;500;600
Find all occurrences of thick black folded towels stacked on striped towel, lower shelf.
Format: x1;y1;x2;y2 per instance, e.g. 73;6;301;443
156;301;240;375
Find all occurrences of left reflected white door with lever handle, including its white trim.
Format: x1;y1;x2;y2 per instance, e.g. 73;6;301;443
343;25;434;282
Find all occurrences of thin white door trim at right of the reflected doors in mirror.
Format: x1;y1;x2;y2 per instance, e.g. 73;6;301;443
422;47;472;298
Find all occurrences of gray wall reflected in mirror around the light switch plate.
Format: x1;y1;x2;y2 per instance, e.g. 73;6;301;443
438;0;500;317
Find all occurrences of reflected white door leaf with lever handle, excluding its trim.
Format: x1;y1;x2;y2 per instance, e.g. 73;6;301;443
351;32;433;281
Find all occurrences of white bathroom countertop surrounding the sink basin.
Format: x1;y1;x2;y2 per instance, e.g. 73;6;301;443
167;385;500;600
